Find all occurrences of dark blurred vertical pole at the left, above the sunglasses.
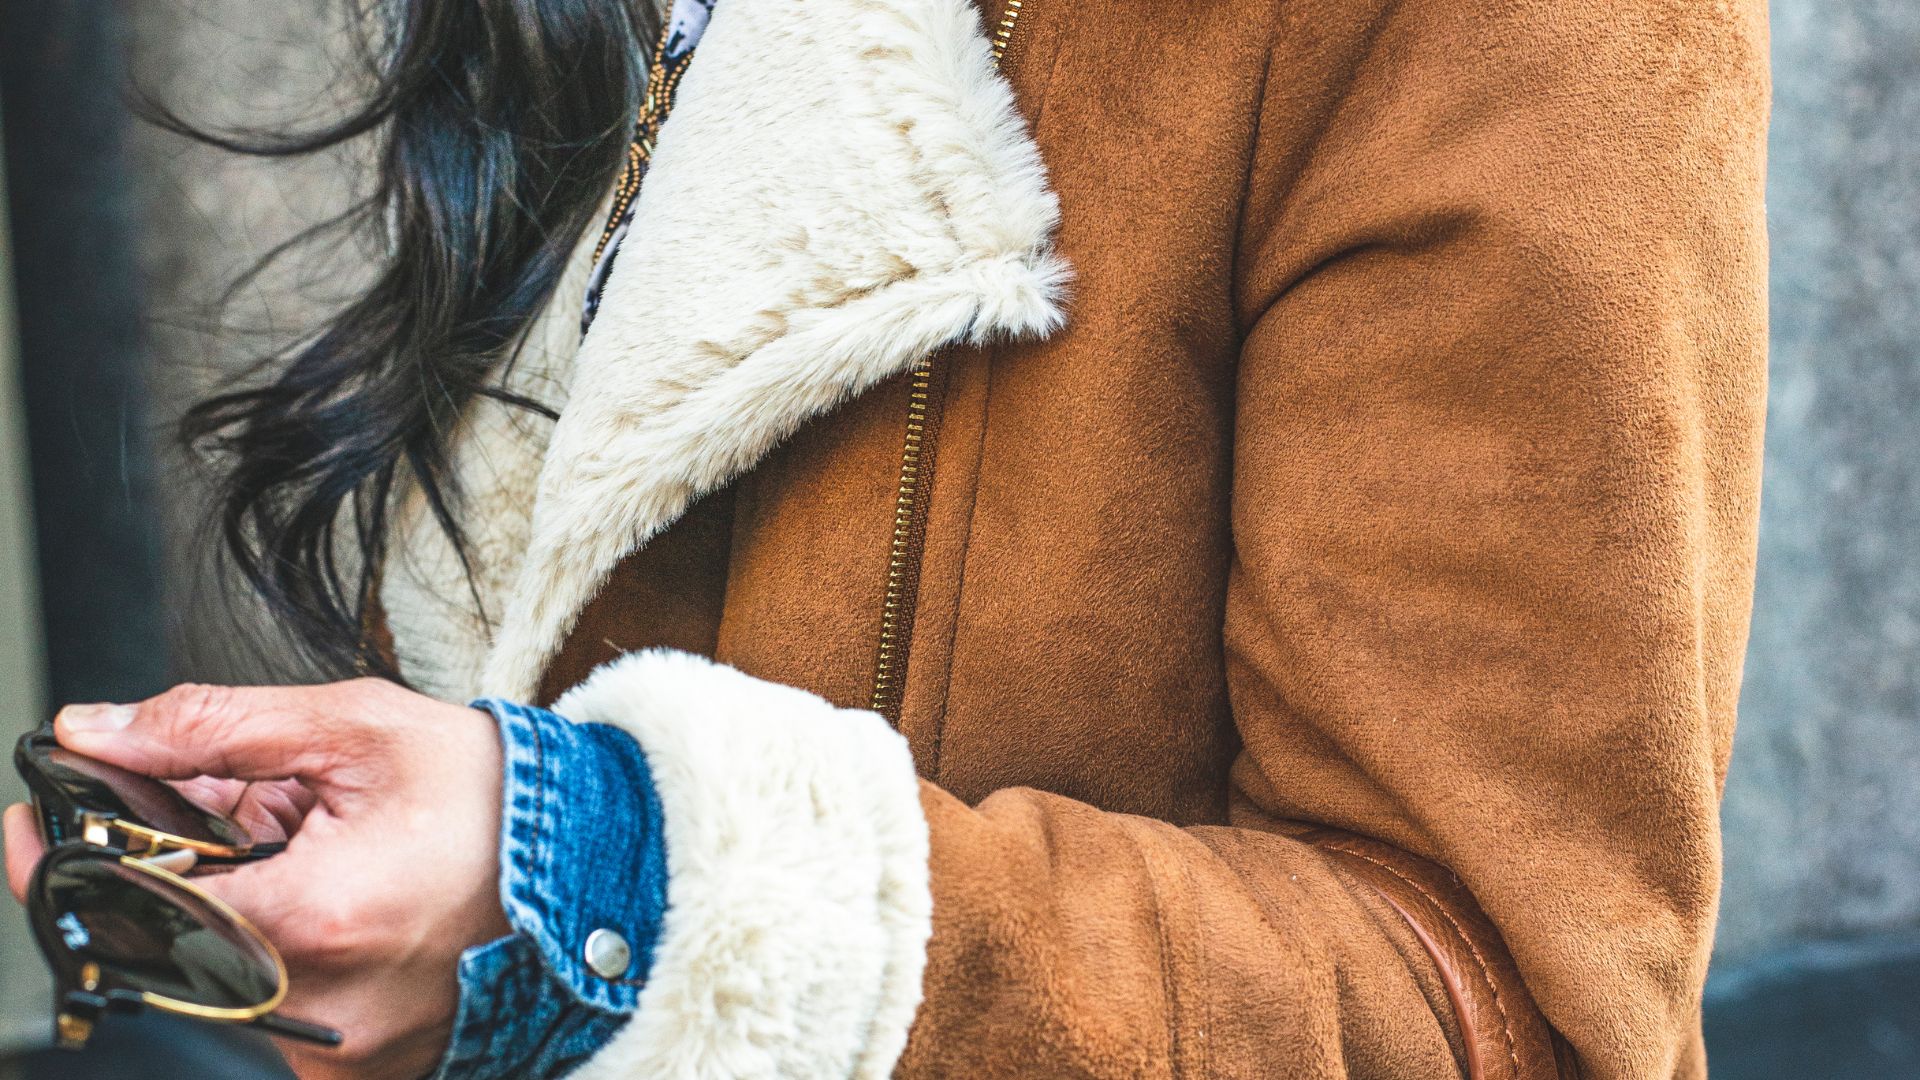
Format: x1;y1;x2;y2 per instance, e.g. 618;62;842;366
0;0;169;705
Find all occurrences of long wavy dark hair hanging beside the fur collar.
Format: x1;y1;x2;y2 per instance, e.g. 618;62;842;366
167;0;657;678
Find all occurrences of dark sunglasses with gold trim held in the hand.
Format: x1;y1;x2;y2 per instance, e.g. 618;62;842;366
13;728;340;1049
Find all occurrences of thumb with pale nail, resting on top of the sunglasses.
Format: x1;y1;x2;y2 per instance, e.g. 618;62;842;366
54;684;353;780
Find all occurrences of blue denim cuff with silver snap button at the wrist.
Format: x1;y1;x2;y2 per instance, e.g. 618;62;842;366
476;698;666;1015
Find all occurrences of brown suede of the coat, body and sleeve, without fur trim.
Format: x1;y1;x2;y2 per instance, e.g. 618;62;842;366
412;0;1768;1080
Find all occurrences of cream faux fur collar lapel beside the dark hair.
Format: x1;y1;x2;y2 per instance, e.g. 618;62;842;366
382;0;1066;700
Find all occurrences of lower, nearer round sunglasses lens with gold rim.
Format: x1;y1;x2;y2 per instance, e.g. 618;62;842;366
33;851;280;1009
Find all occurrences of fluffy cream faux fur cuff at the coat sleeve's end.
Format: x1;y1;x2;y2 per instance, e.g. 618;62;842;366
553;651;933;1080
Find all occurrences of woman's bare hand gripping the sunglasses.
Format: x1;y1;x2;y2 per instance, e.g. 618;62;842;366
8;678;509;1080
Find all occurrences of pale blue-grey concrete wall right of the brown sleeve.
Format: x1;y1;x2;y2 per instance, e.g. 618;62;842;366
1720;0;1920;959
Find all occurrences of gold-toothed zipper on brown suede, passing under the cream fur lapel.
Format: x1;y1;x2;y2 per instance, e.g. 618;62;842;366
868;0;1031;726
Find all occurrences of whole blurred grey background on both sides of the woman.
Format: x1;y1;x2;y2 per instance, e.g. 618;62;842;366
0;0;1920;1078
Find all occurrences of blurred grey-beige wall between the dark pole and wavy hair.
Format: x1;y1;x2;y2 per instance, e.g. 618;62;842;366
121;0;369;682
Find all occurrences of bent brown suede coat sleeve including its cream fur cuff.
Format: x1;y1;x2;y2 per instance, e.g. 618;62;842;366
557;0;1766;1080
